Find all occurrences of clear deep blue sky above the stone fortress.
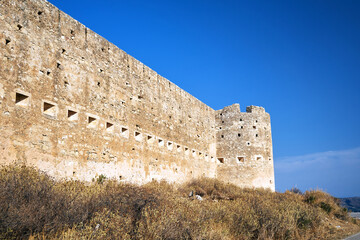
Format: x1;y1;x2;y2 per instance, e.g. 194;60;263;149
50;0;360;197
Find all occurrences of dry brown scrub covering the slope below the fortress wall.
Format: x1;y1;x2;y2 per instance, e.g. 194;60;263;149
0;167;359;239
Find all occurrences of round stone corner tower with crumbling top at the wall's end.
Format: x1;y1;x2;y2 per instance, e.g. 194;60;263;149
216;104;275;191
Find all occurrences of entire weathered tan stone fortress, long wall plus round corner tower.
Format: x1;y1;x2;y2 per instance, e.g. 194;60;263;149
0;0;275;190
